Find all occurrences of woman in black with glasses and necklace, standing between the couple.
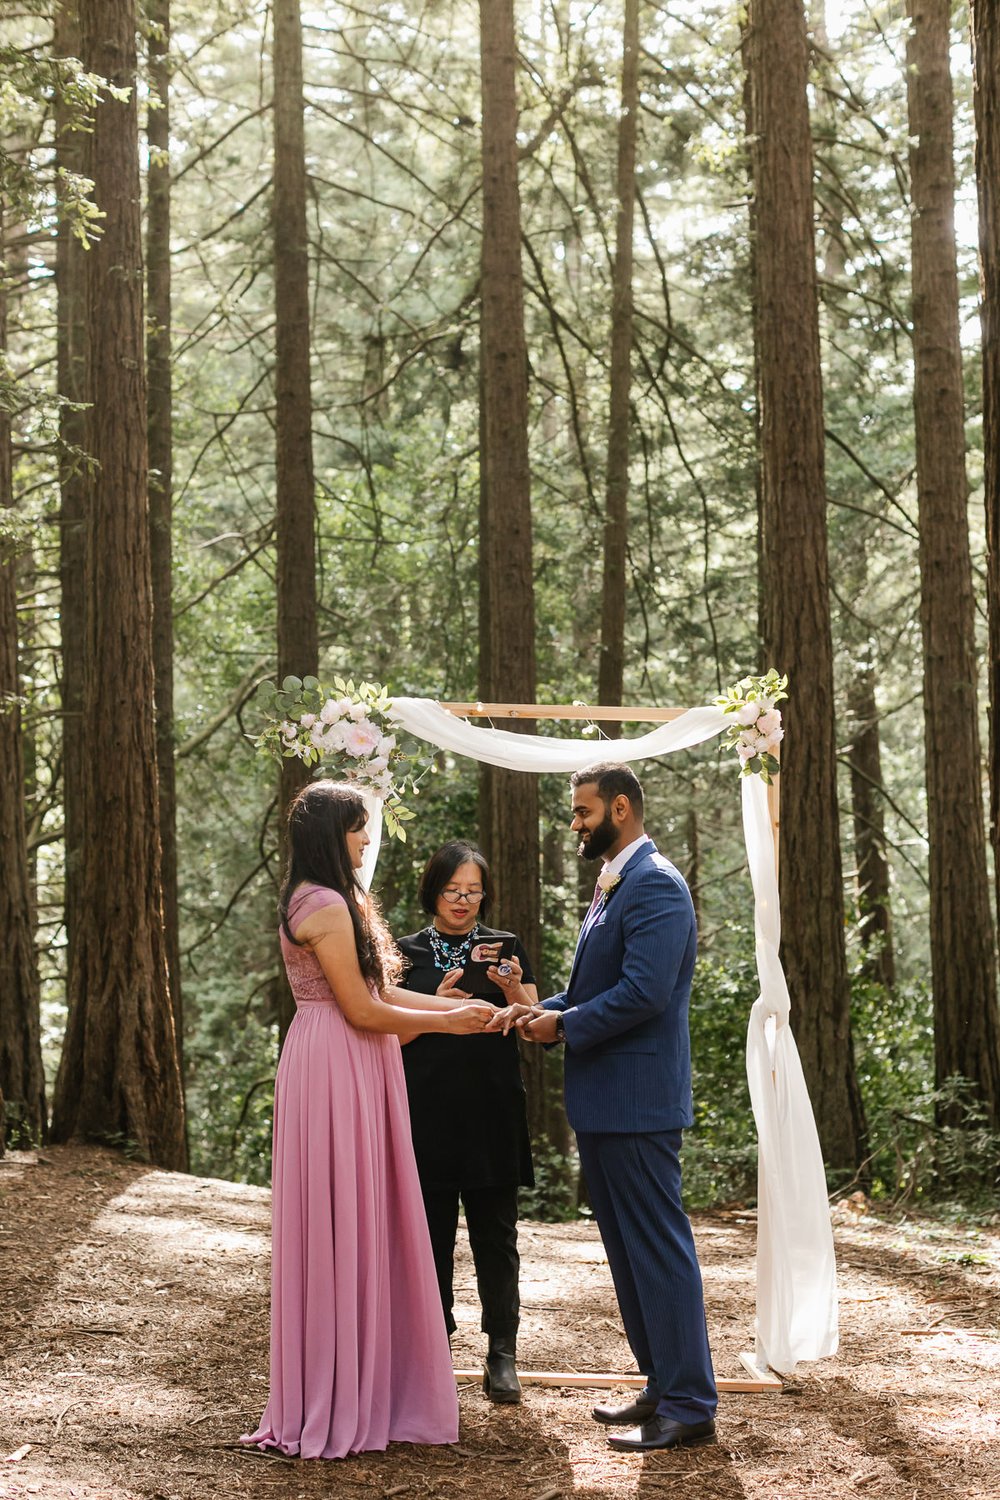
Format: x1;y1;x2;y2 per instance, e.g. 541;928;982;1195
399;839;537;1404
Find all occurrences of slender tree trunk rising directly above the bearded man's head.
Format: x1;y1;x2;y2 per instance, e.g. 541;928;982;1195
597;0;639;720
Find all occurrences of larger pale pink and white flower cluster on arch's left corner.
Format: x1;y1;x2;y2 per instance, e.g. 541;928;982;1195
253;677;417;842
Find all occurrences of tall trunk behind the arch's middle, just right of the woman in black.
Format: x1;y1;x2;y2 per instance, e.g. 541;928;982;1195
480;0;547;1134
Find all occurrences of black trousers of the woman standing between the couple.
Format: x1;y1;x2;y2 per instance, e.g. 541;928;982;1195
423;1187;520;1338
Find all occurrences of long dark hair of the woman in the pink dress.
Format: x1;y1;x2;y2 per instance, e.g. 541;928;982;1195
277;782;402;990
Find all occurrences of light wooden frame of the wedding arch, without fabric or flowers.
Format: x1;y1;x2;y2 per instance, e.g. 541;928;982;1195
439;702;783;1394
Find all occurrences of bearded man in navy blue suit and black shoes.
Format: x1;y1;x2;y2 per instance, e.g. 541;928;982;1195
517;764;717;1452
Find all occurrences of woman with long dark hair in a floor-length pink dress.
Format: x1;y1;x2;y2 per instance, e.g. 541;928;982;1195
243;782;493;1458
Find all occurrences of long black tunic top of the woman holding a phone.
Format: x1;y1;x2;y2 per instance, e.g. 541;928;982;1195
399;926;535;1190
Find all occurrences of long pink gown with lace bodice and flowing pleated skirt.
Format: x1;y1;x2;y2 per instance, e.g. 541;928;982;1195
243;885;459;1458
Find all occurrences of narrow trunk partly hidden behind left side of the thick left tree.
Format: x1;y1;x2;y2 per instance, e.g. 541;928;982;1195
52;3;90;1008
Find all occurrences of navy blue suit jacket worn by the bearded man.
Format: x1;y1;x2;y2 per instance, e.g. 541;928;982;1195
544;840;697;1134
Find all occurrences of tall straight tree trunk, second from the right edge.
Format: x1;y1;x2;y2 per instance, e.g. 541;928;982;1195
907;0;1000;1128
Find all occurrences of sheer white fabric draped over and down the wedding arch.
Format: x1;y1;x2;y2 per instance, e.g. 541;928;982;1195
363;698;837;1373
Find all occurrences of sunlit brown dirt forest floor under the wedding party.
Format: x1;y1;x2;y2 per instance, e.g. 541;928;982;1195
0;1148;1000;1500
